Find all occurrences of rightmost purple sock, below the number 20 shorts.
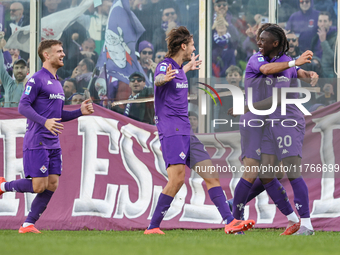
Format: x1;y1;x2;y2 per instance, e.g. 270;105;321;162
290;177;310;218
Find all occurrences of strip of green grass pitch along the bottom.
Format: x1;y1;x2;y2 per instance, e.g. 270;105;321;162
0;229;340;255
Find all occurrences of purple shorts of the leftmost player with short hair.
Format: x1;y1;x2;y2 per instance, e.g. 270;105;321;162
23;149;61;178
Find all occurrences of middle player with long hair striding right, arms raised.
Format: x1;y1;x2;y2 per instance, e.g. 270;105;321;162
144;26;255;234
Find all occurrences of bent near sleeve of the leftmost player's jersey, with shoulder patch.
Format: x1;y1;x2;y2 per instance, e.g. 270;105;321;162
18;78;47;126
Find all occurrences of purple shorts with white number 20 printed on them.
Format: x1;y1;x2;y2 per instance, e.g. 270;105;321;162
261;124;305;161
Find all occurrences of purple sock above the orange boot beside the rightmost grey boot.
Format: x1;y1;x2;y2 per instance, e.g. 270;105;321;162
263;178;293;216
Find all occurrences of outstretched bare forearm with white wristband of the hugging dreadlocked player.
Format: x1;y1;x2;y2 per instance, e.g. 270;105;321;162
260;50;313;75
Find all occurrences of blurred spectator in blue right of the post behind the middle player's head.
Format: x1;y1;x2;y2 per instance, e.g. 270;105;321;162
212;16;236;77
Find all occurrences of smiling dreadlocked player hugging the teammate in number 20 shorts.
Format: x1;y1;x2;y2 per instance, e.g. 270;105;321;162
228;24;317;235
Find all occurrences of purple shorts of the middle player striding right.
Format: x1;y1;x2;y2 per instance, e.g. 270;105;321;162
161;135;210;168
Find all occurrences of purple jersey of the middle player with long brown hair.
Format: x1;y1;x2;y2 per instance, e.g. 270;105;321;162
155;58;190;139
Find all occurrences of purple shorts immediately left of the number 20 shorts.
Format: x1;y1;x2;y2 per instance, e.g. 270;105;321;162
240;112;264;161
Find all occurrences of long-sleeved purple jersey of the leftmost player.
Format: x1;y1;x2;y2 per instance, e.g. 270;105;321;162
19;68;81;151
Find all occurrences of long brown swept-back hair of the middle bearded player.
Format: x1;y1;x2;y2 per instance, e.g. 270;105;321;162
165;26;193;58
